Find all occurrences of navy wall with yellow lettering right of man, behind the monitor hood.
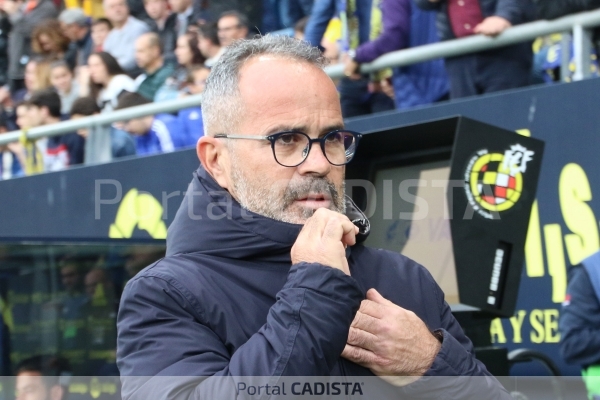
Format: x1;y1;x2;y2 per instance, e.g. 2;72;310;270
349;79;600;375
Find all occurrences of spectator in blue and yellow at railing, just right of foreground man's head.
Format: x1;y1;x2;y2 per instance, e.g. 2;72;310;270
305;0;395;118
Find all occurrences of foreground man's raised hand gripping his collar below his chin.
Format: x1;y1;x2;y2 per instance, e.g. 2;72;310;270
291;208;358;275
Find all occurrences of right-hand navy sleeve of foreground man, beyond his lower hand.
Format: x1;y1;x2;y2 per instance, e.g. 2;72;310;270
403;270;512;400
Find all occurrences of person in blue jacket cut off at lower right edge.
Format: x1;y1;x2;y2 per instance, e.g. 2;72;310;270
558;252;600;400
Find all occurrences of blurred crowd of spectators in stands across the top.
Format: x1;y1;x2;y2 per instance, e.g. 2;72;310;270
0;0;600;179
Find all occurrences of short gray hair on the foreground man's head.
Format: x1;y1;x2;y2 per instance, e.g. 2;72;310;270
202;35;327;136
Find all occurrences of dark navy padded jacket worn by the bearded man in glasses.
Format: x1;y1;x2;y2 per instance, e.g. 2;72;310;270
117;167;510;399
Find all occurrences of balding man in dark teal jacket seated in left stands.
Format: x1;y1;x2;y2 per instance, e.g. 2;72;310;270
135;32;174;100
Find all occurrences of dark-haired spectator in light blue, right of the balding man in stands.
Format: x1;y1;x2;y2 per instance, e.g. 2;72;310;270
156;33;204;101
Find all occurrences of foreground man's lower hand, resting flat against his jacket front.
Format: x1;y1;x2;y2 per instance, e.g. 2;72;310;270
342;289;441;386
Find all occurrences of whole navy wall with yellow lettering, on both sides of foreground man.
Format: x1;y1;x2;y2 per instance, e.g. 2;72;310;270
0;80;600;375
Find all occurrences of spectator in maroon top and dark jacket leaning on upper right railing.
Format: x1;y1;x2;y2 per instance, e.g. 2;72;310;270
415;0;534;98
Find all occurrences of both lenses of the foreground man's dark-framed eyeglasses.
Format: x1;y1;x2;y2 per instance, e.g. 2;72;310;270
273;131;356;167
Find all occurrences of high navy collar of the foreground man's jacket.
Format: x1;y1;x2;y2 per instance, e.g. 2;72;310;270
167;166;370;264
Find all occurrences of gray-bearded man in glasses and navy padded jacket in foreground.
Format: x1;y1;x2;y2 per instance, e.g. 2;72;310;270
117;36;511;400
